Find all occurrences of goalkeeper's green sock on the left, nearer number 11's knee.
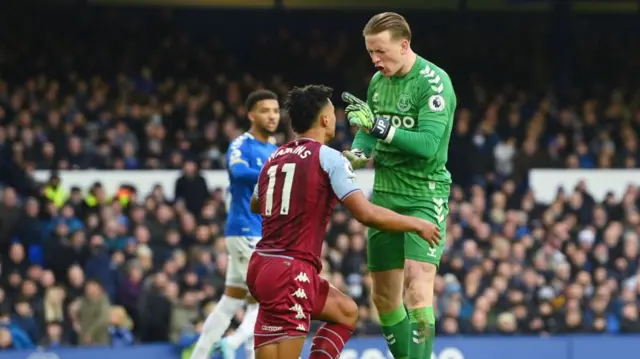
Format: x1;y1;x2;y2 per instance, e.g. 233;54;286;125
379;306;410;359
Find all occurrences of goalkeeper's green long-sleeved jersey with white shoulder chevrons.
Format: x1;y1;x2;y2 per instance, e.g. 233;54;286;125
351;56;456;198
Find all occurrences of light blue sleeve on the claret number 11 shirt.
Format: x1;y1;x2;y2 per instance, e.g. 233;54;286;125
320;146;360;201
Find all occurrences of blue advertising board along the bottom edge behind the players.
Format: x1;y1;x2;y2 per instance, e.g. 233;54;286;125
7;335;640;359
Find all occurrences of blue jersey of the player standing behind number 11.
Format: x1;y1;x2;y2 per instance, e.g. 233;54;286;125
225;132;278;237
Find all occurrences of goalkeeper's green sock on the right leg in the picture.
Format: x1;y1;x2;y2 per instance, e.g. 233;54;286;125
409;307;436;359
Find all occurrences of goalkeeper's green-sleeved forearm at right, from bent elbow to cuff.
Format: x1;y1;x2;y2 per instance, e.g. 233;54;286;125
387;121;446;158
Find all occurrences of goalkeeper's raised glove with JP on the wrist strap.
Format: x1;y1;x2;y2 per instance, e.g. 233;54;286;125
342;92;395;142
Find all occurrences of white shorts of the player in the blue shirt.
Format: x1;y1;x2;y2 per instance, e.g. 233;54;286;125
225;236;260;289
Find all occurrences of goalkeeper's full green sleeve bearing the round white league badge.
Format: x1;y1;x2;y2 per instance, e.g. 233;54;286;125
387;71;456;158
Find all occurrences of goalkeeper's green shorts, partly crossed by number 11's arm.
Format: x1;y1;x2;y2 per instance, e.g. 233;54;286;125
367;192;449;272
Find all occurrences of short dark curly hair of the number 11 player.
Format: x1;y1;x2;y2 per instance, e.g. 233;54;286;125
284;85;333;133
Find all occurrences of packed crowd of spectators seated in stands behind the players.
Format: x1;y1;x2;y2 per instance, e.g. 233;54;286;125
0;5;640;350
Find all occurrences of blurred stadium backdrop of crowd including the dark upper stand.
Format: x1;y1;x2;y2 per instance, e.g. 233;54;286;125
0;0;640;350
